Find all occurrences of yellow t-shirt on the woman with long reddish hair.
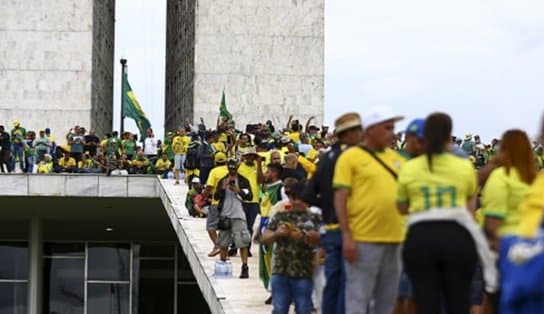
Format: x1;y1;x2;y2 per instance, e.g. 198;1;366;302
482;167;530;235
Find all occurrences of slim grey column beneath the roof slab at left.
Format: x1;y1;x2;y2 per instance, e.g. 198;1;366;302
28;216;43;314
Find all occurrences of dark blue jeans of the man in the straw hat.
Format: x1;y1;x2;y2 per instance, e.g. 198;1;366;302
321;230;346;314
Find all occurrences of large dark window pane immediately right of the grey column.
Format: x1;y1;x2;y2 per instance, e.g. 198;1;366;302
43;258;85;314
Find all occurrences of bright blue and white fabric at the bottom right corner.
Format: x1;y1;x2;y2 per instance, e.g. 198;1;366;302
499;225;544;314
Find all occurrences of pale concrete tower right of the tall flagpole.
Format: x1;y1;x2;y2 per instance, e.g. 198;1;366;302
165;0;324;130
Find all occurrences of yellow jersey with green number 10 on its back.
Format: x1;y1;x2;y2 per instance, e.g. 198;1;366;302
397;153;478;214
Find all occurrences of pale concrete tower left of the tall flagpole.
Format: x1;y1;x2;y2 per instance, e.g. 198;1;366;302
0;0;115;137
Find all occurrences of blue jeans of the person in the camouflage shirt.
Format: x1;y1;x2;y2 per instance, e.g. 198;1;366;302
270;274;314;314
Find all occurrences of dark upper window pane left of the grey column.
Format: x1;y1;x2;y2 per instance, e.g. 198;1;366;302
0;242;28;280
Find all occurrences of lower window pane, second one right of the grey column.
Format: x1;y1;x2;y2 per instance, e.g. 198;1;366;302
87;283;130;314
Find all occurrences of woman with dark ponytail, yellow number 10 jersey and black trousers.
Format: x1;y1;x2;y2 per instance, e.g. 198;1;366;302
397;113;478;314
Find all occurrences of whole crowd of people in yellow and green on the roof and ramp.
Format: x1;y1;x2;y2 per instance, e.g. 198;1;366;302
0;107;544;314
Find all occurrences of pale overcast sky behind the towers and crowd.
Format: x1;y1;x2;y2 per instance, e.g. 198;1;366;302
115;0;544;140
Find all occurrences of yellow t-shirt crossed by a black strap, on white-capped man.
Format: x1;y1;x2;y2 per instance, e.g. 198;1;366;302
333;147;404;243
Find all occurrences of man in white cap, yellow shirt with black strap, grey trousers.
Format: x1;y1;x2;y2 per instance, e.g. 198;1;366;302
333;107;404;314
